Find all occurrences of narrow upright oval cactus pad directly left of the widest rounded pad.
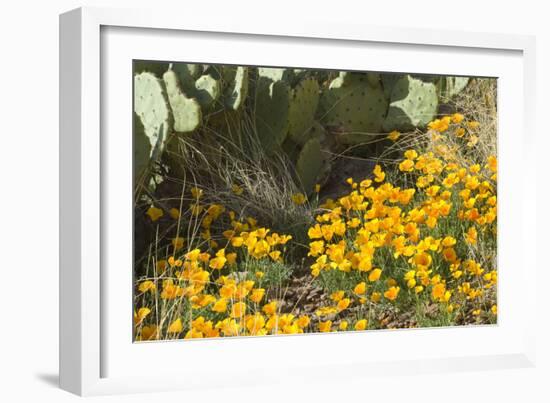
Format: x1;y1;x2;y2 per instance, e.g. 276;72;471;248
288;78;319;144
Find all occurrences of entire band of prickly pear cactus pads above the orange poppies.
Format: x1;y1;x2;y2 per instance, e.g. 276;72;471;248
134;61;468;191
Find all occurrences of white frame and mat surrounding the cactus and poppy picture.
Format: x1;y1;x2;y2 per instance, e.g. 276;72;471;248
60;8;536;395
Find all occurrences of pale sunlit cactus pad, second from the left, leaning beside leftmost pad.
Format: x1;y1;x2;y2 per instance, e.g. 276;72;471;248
163;70;202;133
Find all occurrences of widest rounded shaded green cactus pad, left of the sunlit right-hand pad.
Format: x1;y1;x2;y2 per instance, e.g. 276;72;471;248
319;72;388;133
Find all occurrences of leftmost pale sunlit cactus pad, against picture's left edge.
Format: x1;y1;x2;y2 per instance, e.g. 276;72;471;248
134;72;171;159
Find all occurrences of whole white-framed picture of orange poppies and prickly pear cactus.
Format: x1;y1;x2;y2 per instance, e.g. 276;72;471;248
60;8;536;395
